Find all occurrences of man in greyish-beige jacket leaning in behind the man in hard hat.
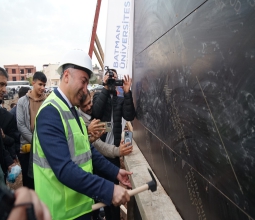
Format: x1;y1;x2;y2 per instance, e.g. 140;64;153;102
79;90;133;158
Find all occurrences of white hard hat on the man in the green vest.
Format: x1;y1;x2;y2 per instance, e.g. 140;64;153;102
57;50;93;77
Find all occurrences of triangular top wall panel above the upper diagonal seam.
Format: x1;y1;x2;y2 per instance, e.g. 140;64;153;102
134;0;206;54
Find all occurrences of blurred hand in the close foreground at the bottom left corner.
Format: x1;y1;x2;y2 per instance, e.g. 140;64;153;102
8;187;51;220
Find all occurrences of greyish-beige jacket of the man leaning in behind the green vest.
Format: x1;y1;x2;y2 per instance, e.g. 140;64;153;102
79;109;120;158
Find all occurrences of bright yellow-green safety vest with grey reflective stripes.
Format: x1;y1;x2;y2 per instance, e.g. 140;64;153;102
33;92;94;220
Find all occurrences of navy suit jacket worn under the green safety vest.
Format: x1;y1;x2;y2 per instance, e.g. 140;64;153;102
36;89;119;219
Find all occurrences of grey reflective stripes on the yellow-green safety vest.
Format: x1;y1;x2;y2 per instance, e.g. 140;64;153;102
33;100;92;168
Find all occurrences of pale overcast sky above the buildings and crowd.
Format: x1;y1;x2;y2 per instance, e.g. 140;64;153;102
0;0;108;70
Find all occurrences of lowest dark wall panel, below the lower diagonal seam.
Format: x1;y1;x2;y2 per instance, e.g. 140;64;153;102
134;120;249;220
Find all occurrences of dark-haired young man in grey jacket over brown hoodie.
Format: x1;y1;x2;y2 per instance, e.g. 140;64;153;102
16;71;47;189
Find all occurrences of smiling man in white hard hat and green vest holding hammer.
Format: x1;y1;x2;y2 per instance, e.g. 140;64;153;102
33;50;132;220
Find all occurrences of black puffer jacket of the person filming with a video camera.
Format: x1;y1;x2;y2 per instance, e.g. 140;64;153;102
92;88;135;147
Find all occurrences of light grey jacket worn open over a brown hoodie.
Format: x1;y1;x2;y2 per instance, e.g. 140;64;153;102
16;95;32;146
